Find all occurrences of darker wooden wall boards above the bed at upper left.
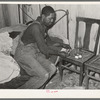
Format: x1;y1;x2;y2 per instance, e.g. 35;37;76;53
0;4;19;28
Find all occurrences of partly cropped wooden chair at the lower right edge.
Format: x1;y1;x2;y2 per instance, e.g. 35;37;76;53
85;55;100;89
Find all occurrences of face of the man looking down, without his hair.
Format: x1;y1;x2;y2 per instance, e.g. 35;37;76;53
43;13;56;27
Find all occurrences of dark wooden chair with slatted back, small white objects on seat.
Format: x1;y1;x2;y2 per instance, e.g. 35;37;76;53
59;17;100;86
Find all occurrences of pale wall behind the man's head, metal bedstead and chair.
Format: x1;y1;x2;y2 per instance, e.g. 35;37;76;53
22;4;100;48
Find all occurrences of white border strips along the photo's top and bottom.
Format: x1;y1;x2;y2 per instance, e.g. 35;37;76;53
0;0;100;100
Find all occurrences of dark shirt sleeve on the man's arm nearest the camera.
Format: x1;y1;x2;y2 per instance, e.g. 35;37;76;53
30;24;59;57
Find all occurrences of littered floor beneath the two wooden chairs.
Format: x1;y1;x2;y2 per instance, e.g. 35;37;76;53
46;70;100;89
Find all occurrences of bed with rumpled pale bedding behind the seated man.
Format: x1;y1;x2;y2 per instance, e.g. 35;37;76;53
0;24;29;89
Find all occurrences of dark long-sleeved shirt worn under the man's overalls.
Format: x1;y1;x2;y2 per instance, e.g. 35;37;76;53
21;17;59;57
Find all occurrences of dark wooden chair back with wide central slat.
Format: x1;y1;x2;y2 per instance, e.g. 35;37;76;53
75;17;100;54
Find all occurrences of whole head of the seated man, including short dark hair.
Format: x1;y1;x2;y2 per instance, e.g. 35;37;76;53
41;6;56;27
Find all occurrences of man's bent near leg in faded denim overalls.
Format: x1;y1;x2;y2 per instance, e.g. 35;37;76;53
15;54;49;89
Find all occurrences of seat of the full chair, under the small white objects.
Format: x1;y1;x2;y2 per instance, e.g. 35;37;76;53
65;49;94;66
